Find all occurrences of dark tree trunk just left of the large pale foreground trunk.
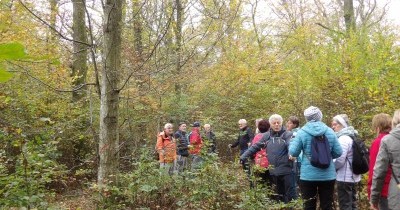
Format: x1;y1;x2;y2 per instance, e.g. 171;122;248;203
72;0;88;101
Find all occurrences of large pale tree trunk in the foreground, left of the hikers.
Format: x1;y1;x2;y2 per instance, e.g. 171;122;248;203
97;0;124;186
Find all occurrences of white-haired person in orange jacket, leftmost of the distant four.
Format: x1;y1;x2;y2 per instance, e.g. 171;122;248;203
156;123;176;175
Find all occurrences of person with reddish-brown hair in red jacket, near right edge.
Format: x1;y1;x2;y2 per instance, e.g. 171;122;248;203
367;113;392;210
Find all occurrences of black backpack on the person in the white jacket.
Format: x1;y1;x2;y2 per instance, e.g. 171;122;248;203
350;136;369;175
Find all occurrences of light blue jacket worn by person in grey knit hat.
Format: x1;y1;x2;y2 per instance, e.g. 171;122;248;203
289;121;342;181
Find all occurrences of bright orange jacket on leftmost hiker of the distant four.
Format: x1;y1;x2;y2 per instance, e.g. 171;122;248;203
156;132;176;163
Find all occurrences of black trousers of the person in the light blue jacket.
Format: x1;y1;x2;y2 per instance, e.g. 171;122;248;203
300;180;335;210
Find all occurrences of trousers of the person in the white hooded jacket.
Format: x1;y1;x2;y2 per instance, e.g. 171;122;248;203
336;182;357;210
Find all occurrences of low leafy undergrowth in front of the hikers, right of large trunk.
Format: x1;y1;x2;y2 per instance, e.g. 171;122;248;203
92;148;299;209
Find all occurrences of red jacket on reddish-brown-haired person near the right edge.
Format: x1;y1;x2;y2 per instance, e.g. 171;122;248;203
367;133;392;199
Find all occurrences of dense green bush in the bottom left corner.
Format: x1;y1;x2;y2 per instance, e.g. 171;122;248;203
0;132;65;208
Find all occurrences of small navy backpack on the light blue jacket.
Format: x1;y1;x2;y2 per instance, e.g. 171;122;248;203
310;134;332;169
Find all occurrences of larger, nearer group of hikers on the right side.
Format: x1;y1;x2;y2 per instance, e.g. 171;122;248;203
236;106;400;210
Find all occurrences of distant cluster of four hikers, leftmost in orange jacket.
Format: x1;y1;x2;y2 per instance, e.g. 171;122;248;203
156;122;216;174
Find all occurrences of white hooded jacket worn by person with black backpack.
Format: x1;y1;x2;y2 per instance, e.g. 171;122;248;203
334;126;361;183
